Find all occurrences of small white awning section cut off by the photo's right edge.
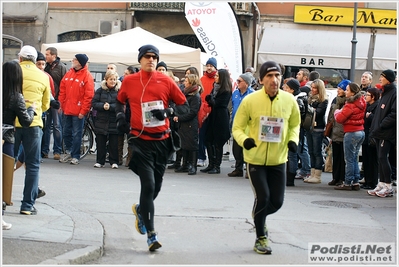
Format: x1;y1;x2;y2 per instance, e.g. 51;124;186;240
373;33;398;70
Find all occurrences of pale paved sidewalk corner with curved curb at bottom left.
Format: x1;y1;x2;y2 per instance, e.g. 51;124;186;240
2;200;104;265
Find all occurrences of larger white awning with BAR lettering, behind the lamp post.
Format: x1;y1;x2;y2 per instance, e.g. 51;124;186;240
258;23;371;70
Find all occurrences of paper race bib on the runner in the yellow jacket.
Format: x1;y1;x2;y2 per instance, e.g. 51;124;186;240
259;116;284;143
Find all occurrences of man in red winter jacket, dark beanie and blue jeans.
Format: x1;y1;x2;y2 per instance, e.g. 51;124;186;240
58;54;94;165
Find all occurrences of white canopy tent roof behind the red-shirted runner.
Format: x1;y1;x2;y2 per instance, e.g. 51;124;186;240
41;27;204;73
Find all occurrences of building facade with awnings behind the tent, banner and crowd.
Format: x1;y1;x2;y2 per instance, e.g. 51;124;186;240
2;2;398;87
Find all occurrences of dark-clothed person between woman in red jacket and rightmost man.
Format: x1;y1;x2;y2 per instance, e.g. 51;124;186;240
360;88;380;189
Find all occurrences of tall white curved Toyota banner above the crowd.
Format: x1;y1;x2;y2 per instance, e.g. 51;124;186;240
185;2;243;88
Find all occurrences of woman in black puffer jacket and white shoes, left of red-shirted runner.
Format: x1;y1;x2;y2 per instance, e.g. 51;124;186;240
91;70;121;169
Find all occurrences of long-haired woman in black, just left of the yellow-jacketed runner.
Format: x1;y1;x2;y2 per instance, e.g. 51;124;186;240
200;69;232;174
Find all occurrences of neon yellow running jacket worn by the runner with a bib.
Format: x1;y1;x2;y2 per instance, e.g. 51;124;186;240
232;88;301;166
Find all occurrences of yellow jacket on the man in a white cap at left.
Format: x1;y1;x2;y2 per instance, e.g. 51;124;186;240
15;61;51;128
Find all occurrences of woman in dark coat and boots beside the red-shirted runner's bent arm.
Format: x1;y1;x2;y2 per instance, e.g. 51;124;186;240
173;74;201;175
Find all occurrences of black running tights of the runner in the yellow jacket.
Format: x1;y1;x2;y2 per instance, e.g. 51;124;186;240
247;163;286;237
